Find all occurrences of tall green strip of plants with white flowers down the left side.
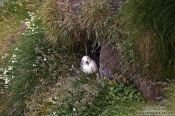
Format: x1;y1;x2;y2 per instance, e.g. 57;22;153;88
0;14;44;114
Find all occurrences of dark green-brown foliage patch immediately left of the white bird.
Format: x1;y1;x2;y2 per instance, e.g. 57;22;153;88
33;30;81;83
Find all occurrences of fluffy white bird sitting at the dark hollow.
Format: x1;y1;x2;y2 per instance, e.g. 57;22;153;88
81;56;98;74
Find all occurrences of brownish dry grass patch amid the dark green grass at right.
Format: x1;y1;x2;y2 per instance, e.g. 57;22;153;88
135;31;162;79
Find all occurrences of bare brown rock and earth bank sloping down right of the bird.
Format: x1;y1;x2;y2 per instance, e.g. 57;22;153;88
100;39;164;102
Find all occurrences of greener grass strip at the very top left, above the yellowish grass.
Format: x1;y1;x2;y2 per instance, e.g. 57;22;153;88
0;0;43;22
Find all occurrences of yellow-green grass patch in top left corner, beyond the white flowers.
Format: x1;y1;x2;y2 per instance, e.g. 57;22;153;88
0;0;42;63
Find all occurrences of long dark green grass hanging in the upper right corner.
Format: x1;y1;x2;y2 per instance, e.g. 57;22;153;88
122;0;175;79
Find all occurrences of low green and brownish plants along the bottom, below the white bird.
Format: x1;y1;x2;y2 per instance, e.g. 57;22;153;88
23;74;144;116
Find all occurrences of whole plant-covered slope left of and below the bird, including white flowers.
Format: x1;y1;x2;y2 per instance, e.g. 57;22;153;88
2;13;144;116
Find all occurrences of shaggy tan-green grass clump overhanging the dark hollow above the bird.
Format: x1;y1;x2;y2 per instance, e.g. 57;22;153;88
43;0;123;48
